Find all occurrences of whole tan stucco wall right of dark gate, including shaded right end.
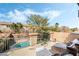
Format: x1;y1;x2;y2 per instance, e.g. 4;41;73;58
50;32;79;43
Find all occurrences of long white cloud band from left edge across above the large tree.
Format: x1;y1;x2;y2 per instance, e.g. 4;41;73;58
0;9;61;23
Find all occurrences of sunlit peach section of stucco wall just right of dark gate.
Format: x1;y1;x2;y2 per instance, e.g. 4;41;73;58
50;32;70;42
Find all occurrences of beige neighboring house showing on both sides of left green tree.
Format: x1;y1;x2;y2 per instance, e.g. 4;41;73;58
0;22;31;33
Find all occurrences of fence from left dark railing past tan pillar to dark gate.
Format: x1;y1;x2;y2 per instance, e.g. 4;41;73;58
0;32;50;53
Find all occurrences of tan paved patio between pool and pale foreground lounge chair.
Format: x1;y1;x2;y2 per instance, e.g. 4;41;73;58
7;46;36;56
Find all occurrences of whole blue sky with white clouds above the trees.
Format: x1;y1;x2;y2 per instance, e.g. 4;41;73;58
0;3;79;28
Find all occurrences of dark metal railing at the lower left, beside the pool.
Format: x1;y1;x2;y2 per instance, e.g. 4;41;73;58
0;38;29;53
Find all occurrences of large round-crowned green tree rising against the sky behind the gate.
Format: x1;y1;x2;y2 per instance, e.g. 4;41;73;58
28;15;48;32
